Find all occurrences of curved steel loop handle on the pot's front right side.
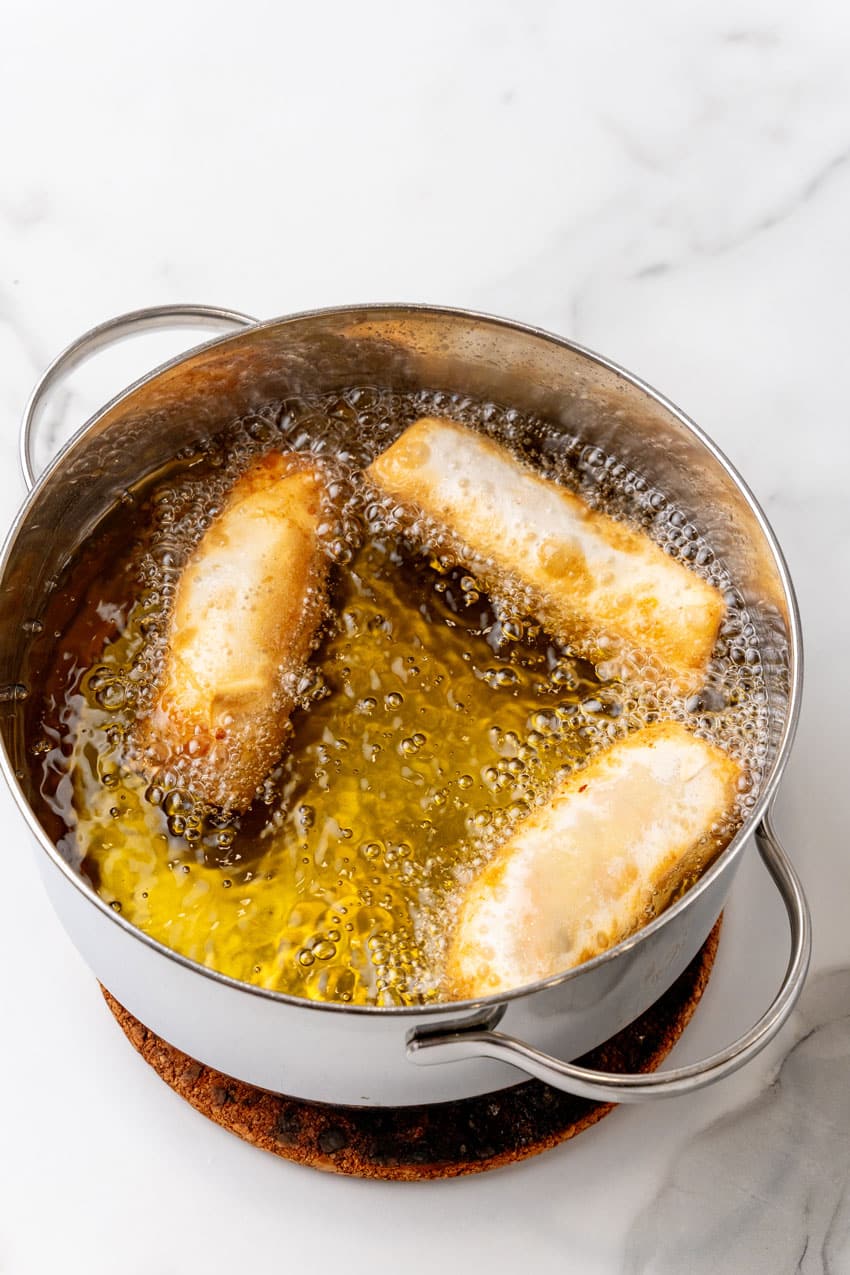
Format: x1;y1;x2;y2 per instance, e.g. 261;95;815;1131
408;816;812;1103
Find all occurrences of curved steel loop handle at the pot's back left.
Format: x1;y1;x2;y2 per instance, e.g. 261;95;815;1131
20;305;257;491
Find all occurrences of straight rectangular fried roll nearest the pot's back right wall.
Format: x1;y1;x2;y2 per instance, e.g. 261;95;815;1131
367;417;725;694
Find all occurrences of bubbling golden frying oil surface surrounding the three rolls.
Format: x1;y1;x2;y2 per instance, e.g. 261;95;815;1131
32;389;767;1005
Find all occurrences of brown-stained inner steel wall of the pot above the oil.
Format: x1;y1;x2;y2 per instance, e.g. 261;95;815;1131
0;307;793;826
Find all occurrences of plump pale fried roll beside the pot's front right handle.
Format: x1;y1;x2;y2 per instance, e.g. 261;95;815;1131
446;722;742;1000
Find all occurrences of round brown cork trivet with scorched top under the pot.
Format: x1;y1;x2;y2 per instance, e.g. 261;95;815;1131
103;921;720;1181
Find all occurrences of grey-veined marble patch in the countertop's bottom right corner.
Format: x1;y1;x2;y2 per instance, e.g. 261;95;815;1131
624;969;850;1275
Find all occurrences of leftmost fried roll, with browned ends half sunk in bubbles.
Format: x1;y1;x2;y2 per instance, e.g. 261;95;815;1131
138;453;326;810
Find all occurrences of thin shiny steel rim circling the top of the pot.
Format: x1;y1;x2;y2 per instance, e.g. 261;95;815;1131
0;302;803;1020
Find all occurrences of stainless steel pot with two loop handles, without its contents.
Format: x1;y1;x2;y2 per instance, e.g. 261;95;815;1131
0;306;810;1105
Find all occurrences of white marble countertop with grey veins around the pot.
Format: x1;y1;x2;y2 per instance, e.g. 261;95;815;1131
0;0;850;1275
